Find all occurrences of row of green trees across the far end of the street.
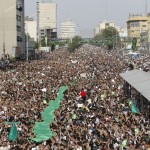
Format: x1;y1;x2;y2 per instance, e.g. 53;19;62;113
28;27;137;52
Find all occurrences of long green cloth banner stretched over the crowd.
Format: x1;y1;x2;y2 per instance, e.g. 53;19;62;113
30;86;68;142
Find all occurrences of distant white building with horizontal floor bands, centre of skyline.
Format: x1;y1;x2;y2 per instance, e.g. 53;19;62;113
60;21;79;39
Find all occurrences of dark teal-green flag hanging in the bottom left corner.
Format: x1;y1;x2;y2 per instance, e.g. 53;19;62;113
8;123;18;142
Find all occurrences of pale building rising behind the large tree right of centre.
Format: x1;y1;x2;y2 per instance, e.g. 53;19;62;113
94;20;115;36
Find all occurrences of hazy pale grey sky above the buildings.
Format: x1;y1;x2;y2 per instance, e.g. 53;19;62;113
25;0;150;37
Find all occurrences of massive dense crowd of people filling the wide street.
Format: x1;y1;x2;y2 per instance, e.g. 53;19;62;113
0;45;150;150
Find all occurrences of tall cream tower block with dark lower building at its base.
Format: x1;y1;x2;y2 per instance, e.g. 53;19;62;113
37;0;57;41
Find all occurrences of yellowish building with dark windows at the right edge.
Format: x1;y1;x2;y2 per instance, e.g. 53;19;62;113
127;14;148;47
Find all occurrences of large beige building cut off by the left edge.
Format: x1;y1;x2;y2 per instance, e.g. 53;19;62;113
0;0;25;57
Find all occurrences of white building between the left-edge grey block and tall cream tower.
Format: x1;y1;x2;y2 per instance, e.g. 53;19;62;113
25;17;37;41
